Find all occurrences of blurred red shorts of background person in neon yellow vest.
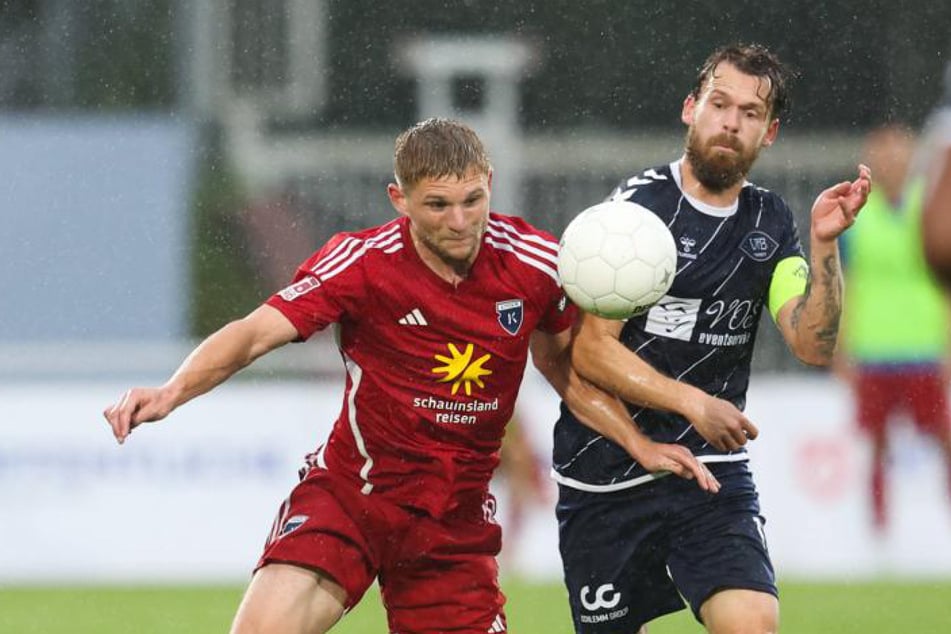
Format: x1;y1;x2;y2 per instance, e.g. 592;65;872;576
855;366;951;435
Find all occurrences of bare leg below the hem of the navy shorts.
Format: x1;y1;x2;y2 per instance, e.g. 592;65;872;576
700;589;779;634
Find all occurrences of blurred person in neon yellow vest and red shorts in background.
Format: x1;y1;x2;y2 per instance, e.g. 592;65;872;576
838;125;951;531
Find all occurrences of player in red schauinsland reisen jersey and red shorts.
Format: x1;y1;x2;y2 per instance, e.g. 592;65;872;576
104;119;719;634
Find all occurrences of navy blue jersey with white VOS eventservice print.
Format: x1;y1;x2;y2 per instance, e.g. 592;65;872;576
554;162;803;491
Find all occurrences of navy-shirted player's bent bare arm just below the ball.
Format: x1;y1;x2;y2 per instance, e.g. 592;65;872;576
572;313;759;451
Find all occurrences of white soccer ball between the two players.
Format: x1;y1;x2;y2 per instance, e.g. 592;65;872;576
558;200;677;319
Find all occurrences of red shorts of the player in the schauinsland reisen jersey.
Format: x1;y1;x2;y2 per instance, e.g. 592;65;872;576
258;469;506;634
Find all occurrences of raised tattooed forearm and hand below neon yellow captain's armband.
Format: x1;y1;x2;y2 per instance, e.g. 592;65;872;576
777;165;872;365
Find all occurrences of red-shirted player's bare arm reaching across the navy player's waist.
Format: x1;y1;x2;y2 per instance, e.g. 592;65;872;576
531;320;720;493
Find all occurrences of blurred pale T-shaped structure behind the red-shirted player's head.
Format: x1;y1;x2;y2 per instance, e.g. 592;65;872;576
400;35;535;215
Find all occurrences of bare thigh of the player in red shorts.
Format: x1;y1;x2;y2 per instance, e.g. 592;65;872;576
231;564;347;634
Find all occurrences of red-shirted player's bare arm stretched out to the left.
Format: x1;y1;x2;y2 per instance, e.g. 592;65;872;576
103;304;298;444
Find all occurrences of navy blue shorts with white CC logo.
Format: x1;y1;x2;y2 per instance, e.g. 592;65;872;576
557;462;778;634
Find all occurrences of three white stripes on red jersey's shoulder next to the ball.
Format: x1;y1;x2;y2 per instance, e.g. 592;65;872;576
484;212;558;282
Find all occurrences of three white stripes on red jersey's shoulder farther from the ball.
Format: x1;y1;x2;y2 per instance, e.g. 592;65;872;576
305;217;405;277
